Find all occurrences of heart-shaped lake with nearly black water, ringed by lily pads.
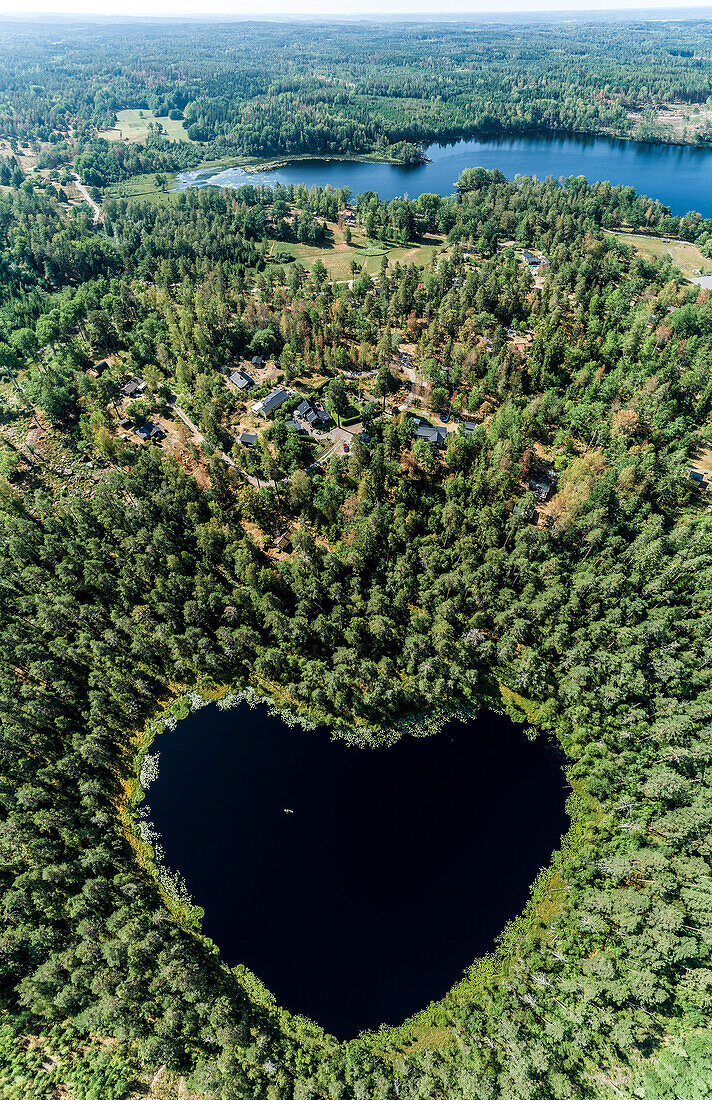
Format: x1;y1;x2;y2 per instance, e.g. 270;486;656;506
147;705;568;1038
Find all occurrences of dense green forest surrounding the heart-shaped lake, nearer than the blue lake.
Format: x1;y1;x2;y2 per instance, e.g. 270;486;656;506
0;144;712;1100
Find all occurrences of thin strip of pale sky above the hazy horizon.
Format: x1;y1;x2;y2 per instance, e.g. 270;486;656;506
0;0;712;21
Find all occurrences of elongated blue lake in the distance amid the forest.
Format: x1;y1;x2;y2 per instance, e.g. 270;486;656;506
176;134;712;218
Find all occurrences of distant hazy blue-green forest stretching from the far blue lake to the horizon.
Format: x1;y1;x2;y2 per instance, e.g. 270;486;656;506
5;21;712;187
